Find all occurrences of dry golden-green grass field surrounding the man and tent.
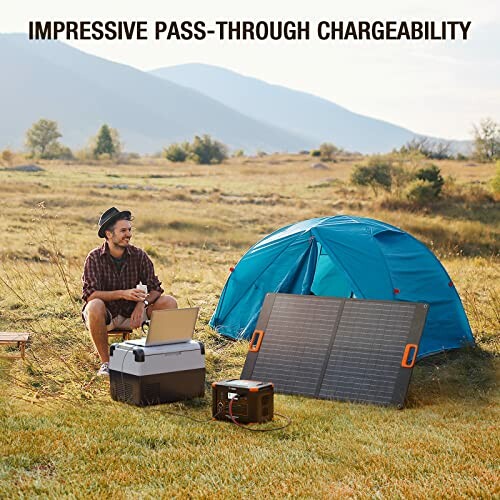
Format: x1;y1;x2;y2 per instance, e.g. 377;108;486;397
0;155;500;498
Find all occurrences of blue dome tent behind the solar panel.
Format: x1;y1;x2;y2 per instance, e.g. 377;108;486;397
210;215;474;358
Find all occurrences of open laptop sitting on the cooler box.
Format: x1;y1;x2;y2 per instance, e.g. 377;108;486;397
125;307;200;347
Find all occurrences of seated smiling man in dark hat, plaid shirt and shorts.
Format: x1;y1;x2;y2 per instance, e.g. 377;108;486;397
82;207;177;376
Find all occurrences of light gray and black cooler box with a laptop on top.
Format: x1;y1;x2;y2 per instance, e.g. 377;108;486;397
109;340;205;406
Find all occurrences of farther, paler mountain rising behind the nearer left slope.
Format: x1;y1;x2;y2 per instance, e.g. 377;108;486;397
151;64;428;153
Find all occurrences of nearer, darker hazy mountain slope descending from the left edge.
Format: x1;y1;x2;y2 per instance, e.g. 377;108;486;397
0;34;315;153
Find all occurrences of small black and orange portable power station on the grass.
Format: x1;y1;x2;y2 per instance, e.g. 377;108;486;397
212;379;274;424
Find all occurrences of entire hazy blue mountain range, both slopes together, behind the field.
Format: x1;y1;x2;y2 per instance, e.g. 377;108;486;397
0;33;466;153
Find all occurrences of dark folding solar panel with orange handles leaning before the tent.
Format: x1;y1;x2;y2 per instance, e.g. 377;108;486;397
241;294;428;407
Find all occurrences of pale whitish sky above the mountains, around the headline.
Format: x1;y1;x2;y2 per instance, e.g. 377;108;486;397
0;0;500;139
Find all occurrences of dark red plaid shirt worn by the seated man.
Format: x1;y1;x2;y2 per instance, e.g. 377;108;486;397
82;242;163;318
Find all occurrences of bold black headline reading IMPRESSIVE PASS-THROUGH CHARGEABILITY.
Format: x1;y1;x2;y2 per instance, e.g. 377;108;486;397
28;20;472;41
